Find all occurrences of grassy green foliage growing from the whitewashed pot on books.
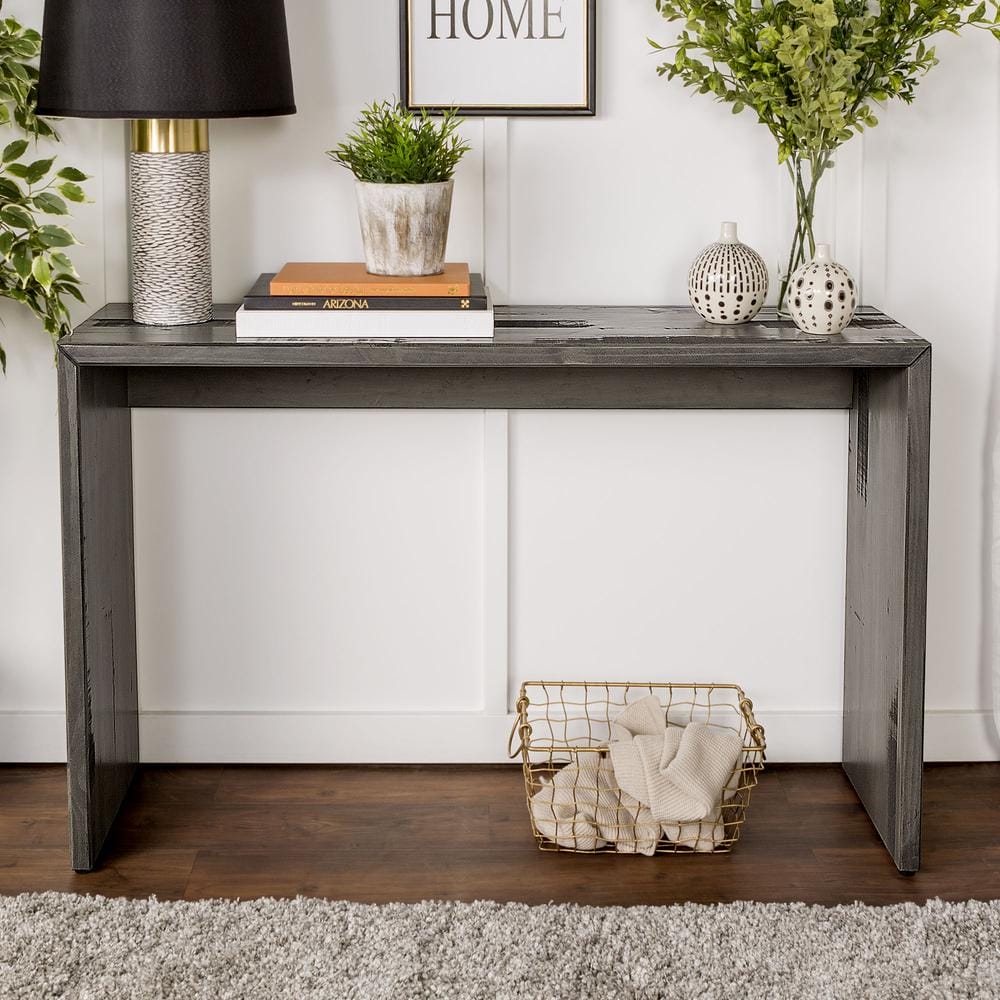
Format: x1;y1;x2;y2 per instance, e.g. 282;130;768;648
326;101;471;184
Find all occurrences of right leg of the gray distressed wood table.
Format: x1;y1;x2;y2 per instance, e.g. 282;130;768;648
843;348;931;872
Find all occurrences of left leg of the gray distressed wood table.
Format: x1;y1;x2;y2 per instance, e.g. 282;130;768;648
59;354;139;871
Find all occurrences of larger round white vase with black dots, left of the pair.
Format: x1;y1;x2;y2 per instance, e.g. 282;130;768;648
688;222;767;326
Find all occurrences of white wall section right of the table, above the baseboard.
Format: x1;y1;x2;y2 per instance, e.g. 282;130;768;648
866;32;1000;728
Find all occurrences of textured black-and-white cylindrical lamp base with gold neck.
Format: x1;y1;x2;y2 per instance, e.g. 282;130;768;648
129;121;212;326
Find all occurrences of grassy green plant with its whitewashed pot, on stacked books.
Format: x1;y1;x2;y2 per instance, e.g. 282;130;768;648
327;101;471;275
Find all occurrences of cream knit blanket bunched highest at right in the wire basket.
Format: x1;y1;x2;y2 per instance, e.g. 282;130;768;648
611;695;743;824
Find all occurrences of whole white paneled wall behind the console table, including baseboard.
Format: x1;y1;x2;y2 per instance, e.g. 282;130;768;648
0;0;1000;760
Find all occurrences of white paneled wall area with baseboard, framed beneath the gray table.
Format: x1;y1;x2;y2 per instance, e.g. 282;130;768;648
125;409;860;762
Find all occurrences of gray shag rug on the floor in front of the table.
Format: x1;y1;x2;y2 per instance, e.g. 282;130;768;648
0;893;1000;1000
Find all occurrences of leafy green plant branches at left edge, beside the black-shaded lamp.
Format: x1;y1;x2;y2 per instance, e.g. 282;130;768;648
0;6;87;371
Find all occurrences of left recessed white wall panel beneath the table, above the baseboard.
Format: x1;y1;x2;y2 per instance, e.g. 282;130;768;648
133;410;484;716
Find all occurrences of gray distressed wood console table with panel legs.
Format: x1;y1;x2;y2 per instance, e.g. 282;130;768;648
59;305;931;872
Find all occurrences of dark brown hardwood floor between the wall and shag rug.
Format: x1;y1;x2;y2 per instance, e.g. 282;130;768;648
0;764;1000;905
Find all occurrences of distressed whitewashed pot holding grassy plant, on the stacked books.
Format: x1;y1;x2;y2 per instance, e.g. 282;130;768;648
356;181;455;276
